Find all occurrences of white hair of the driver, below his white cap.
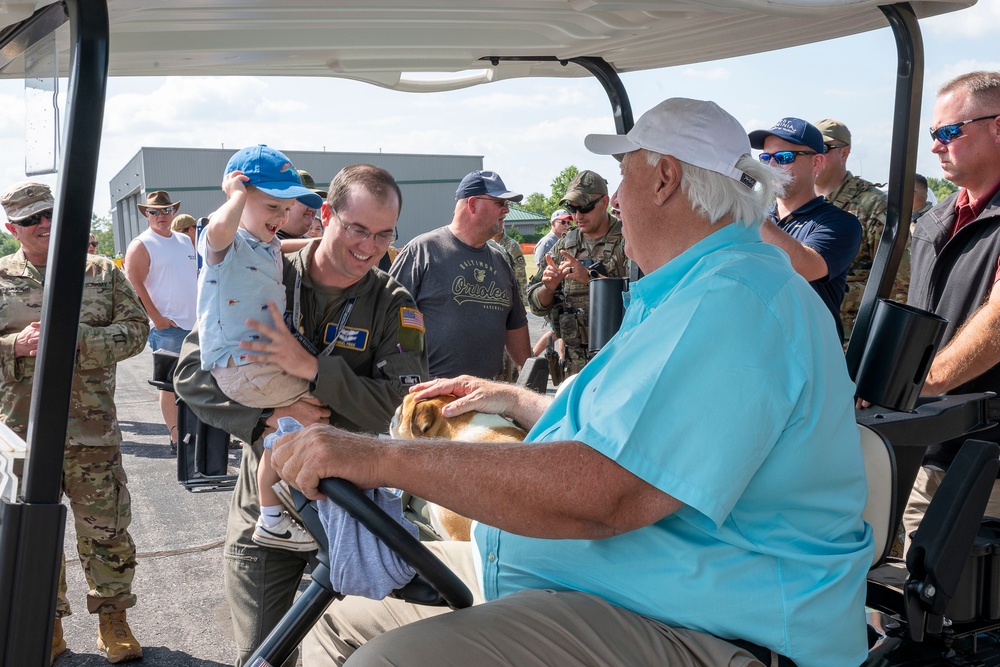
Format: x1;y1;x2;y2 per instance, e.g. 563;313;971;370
646;151;788;227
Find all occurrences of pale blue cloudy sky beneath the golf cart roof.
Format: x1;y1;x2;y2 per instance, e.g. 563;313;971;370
0;0;1000;222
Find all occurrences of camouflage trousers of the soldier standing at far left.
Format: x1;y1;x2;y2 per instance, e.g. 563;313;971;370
56;445;135;618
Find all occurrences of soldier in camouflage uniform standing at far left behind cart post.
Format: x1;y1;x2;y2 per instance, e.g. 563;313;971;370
0;181;149;662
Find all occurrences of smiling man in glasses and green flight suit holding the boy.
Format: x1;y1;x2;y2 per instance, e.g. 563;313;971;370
174;165;428;665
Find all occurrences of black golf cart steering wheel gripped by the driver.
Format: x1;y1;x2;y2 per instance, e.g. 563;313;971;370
319;477;472;609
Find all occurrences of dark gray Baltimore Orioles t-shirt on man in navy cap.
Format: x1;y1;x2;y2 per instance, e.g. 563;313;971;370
389;227;528;378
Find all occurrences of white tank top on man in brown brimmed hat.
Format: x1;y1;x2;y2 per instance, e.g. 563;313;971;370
139;229;198;329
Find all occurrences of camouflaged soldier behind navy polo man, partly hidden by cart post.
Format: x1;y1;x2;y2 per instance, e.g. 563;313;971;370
816;118;910;347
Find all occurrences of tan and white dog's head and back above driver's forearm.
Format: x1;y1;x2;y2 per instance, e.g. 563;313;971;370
389;394;526;441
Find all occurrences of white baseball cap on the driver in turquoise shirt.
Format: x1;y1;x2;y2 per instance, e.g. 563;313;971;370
583;97;757;188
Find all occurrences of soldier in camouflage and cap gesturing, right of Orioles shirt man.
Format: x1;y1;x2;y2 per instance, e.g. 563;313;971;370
528;171;628;375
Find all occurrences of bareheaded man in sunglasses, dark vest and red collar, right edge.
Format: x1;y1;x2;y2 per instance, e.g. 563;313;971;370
903;72;1000;548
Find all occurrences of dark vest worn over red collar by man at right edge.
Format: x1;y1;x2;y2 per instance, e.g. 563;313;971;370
907;193;1000;464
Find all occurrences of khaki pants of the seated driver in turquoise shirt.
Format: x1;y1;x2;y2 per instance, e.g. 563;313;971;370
303;542;761;667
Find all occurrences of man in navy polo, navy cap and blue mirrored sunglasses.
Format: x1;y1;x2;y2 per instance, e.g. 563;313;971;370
750;118;861;342
